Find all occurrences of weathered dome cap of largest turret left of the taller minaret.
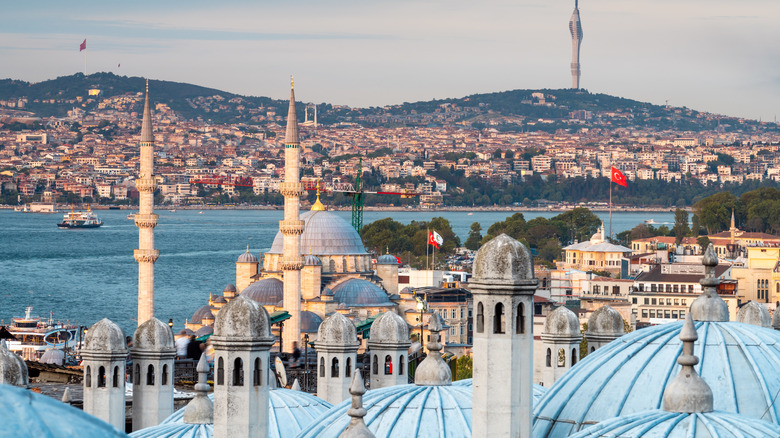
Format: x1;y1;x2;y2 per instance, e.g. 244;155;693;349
214;296;271;339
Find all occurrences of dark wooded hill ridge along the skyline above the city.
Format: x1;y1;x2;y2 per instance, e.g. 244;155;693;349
0;72;780;132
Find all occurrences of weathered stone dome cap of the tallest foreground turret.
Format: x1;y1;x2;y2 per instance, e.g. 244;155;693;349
472;234;534;284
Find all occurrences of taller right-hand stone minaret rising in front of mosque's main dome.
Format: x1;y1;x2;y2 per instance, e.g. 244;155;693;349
279;77;303;351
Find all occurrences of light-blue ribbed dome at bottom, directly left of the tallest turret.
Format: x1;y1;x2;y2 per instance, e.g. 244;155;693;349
298;385;472;438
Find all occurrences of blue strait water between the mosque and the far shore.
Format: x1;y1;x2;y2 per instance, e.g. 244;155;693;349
0;210;674;334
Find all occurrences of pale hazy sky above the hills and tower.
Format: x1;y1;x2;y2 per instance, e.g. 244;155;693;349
0;0;780;121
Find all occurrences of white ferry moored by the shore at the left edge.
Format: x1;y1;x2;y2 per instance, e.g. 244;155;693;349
5;307;79;360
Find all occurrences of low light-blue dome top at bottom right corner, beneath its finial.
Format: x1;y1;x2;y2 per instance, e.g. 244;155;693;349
571;410;780;438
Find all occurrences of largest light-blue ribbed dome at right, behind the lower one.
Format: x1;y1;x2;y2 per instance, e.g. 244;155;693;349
533;322;780;438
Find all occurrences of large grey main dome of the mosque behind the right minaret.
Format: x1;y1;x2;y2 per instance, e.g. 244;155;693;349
268;211;367;256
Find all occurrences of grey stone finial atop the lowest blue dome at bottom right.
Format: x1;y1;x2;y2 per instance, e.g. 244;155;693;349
663;313;712;414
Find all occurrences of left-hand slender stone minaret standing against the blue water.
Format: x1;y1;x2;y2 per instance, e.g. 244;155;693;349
133;80;160;326
